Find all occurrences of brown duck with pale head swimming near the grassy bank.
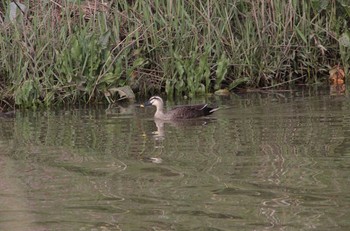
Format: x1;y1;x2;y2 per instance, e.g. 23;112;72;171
141;96;219;120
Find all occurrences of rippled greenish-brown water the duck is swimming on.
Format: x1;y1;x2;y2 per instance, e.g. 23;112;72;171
0;94;350;230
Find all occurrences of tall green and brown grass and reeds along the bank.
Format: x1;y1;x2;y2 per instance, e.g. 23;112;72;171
0;0;350;107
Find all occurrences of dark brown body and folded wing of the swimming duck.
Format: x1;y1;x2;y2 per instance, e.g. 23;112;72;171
168;104;218;119
